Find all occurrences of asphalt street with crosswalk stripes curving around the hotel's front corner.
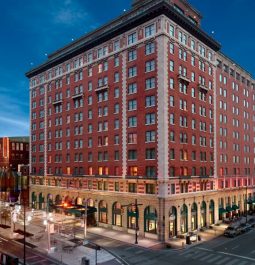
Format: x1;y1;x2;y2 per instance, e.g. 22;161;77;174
88;230;255;265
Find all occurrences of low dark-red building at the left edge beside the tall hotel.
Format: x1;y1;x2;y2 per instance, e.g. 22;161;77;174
0;137;29;201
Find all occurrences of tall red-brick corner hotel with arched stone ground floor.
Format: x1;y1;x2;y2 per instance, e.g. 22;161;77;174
26;0;255;241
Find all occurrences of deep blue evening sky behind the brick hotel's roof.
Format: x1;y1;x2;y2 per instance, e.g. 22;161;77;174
0;0;255;136
